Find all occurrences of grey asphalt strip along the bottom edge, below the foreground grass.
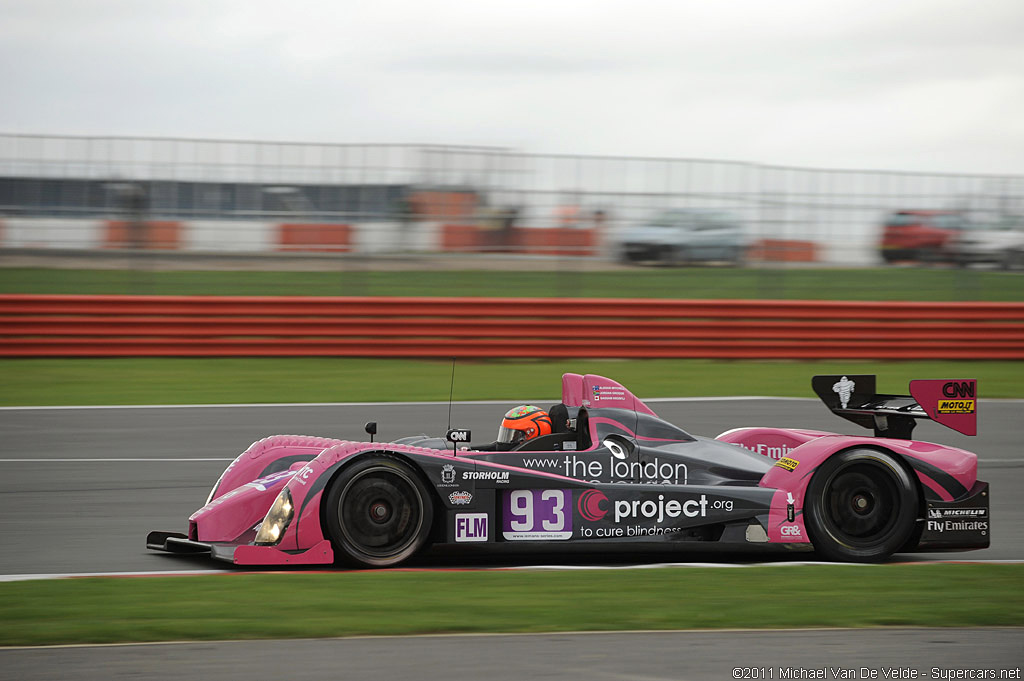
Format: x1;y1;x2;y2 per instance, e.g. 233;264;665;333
0;629;1022;681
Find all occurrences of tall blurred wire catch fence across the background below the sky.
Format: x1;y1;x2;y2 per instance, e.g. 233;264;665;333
0;134;1024;264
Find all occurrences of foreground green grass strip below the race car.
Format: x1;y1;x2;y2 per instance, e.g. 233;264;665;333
0;564;1024;645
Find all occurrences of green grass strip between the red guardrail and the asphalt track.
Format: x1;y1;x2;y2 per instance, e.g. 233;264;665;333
0;357;1024;407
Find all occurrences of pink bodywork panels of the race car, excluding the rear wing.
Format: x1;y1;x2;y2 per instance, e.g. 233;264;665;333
188;374;978;565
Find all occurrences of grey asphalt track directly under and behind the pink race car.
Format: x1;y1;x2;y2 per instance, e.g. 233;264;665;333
0;398;1024;579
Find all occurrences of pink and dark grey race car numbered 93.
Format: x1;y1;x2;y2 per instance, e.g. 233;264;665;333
146;374;990;567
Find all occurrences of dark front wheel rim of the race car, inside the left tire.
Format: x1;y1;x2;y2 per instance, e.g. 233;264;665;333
338;466;423;558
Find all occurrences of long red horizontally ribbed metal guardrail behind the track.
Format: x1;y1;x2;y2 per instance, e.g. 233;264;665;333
0;295;1024;359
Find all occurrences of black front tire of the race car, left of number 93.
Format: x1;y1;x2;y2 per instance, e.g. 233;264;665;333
324;455;433;567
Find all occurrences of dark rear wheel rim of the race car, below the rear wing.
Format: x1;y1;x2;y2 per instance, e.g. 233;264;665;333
821;462;900;548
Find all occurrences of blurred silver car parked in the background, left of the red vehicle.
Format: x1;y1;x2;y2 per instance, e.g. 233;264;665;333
616;209;744;264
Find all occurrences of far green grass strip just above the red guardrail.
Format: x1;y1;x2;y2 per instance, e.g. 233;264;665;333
6;259;1024;301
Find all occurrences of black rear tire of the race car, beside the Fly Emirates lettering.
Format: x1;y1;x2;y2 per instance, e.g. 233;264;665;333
804;450;919;562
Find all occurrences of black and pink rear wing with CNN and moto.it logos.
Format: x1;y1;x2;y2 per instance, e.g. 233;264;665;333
811;374;978;439
